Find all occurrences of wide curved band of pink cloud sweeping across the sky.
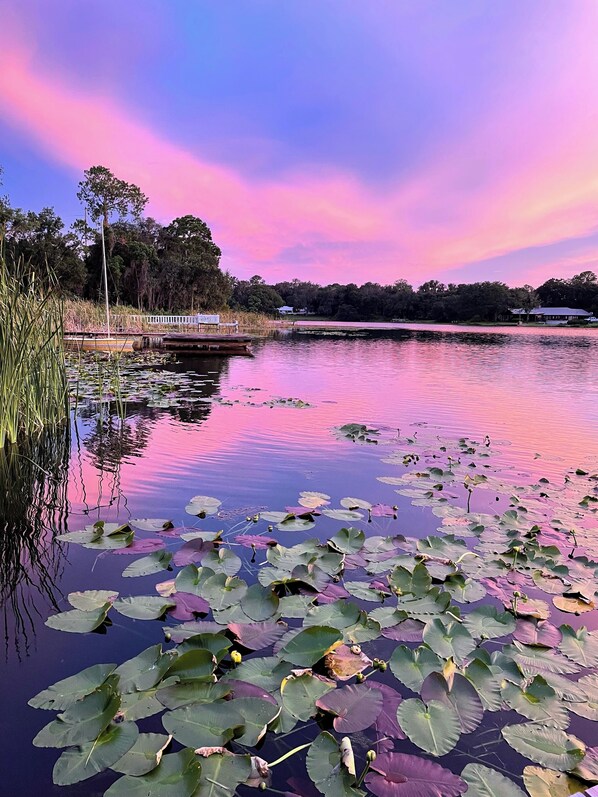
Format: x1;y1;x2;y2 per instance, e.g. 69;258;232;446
0;15;598;282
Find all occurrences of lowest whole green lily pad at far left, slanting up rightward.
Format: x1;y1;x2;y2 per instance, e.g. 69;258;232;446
52;722;139;786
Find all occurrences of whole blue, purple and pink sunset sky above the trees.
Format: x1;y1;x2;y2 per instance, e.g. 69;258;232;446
0;0;598;286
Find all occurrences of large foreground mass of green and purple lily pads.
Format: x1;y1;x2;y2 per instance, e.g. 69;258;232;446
30;424;598;797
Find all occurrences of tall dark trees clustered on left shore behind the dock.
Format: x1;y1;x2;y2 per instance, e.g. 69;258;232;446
0;166;234;312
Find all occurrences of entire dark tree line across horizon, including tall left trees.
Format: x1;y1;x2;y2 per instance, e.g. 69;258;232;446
0;166;598;322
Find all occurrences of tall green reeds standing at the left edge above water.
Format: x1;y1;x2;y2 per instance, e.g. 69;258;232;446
0;253;69;448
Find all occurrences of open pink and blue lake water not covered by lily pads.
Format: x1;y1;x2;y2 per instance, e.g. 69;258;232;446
0;325;598;797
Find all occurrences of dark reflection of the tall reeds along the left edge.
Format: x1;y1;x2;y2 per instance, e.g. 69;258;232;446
0;427;70;656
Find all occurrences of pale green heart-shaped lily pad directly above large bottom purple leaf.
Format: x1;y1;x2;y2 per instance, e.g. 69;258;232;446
397;698;461;756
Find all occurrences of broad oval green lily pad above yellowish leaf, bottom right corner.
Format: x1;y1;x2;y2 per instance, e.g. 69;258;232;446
501;722;586;772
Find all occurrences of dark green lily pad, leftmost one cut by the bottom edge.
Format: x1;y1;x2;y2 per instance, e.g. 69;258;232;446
104;750;201;797
